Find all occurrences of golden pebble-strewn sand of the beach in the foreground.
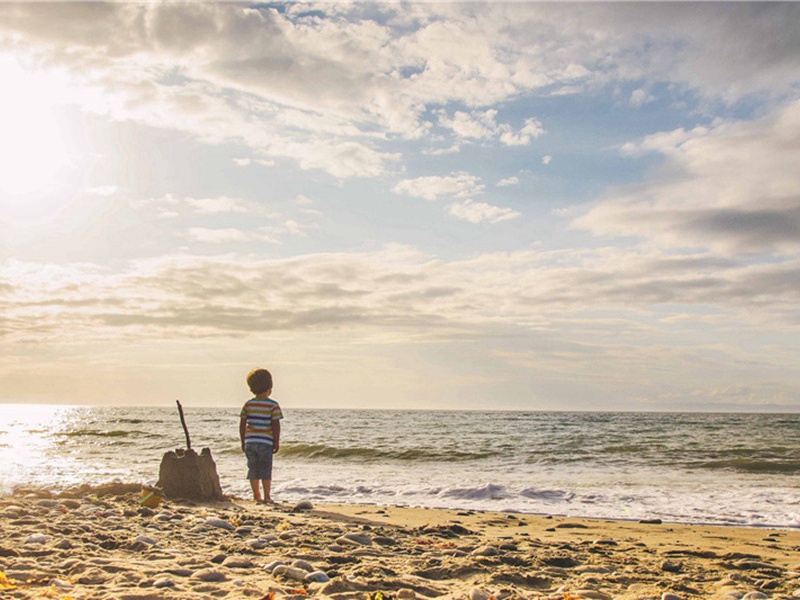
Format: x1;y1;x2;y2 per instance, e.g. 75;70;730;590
0;484;800;600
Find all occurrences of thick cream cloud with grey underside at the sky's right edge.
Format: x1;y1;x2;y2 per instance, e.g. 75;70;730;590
574;102;800;254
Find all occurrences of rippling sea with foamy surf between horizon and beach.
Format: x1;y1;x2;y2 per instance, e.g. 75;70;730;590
0;404;800;528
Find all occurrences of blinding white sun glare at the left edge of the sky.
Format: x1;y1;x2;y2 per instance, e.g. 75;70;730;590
0;56;69;198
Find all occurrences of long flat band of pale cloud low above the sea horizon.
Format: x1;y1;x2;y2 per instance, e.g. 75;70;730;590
0;244;800;346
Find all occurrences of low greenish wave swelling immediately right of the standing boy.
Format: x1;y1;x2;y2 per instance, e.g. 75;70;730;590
281;443;499;462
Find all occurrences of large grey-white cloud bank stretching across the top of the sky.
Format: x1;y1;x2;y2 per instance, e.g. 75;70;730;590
0;3;800;185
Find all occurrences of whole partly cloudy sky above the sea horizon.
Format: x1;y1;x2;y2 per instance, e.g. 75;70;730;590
0;2;800;411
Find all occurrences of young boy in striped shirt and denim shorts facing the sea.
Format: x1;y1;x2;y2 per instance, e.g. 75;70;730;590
239;369;283;504
